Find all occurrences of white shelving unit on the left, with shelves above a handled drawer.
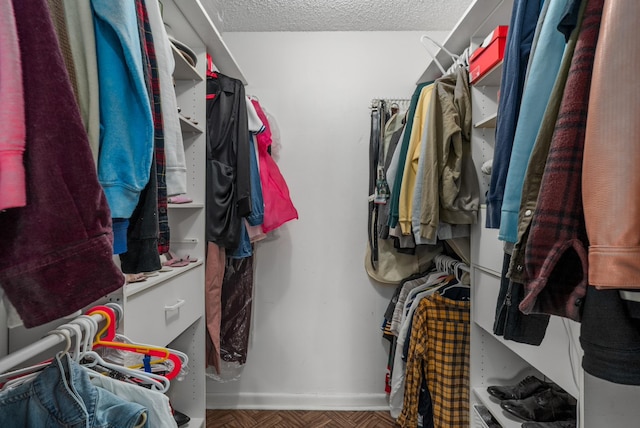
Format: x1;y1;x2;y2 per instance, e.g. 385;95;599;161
0;0;246;428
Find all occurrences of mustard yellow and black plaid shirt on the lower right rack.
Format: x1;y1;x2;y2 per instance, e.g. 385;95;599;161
397;293;471;428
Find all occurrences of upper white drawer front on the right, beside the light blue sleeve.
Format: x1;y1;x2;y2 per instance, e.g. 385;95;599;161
471;206;504;275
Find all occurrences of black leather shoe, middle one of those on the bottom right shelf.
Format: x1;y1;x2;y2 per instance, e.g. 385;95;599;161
500;388;577;422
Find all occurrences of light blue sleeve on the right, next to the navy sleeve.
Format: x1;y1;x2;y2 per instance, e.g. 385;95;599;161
494;0;567;242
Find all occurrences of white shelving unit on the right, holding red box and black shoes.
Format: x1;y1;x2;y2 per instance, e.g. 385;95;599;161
419;0;587;428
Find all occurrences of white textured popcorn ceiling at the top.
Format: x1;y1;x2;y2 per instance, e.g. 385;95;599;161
202;0;472;32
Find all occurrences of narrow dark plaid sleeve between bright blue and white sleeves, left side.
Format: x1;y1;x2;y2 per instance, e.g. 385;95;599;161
136;0;170;254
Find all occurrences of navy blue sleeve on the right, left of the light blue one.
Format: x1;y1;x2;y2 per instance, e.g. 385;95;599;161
486;0;544;229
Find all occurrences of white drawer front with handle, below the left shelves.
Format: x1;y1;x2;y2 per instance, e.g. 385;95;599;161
124;265;204;346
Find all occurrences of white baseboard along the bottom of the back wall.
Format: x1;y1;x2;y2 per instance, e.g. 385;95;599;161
207;392;389;411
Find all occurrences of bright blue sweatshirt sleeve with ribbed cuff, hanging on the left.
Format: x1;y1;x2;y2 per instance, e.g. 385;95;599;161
91;0;154;218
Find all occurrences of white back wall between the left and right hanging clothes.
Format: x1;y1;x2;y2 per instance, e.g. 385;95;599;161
207;32;447;409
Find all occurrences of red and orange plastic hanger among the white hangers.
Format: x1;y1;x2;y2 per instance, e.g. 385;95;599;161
87;306;182;379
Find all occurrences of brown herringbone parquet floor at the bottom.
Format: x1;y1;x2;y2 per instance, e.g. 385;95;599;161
206;410;397;428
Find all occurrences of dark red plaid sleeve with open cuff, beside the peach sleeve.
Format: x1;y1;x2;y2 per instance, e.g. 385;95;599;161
520;0;604;320
